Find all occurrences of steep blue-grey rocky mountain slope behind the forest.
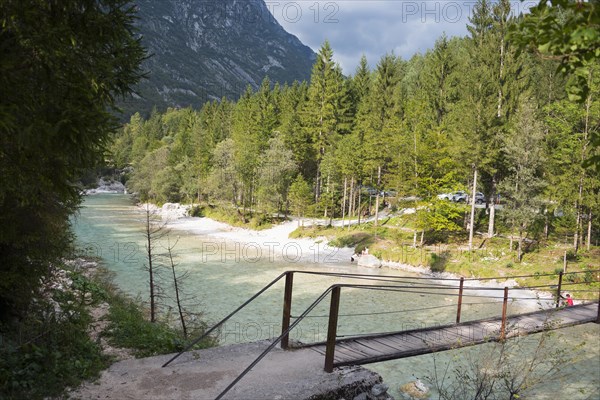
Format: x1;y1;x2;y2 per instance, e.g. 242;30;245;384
120;0;315;115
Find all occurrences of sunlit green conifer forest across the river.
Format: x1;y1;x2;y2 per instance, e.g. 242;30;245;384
111;1;600;253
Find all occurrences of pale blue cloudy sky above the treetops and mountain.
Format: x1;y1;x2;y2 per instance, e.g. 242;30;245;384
265;0;537;74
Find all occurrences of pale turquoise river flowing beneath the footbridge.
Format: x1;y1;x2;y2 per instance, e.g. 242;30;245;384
73;194;600;399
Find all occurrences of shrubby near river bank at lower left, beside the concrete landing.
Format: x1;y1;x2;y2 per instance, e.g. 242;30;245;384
0;258;215;399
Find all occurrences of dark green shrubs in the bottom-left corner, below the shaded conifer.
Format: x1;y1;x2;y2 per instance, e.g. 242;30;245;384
0;273;109;399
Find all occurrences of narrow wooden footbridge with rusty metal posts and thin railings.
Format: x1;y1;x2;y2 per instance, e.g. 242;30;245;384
163;270;600;400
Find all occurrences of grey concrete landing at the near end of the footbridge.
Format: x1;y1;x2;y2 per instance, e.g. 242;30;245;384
71;341;381;400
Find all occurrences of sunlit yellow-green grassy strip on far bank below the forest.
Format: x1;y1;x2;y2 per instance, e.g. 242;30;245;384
291;222;600;300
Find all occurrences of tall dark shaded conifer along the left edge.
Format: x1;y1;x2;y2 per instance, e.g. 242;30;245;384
0;0;145;320
